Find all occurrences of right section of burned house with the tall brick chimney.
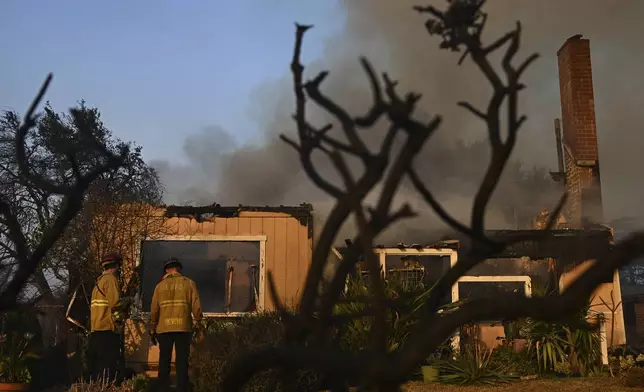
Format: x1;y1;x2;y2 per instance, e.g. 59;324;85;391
336;35;626;360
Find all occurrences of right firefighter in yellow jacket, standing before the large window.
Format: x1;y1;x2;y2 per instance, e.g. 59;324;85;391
150;257;202;391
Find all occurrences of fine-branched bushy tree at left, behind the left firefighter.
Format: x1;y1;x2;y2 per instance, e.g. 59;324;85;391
0;97;162;347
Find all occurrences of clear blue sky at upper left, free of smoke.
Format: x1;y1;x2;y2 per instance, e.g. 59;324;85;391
0;0;344;159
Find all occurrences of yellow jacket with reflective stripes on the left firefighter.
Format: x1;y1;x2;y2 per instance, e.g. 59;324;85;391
90;272;121;332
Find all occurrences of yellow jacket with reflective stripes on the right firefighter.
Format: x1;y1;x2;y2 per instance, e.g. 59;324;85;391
150;273;202;333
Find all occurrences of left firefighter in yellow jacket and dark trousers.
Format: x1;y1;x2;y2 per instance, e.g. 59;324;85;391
89;253;122;381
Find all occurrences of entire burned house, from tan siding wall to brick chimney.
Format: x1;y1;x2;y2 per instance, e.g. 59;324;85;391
69;36;625;371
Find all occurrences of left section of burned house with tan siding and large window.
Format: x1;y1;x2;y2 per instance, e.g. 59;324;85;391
118;205;313;371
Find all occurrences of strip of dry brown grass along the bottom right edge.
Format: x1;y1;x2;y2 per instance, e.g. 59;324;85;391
403;377;637;392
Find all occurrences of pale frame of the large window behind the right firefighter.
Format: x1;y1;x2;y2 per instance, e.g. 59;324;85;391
135;234;268;318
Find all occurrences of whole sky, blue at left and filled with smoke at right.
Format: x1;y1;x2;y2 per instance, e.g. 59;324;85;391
0;0;644;224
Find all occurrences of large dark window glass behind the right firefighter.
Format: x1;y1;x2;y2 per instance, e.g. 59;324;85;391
141;241;260;313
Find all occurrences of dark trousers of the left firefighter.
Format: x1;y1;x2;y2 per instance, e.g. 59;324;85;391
89;331;121;381
